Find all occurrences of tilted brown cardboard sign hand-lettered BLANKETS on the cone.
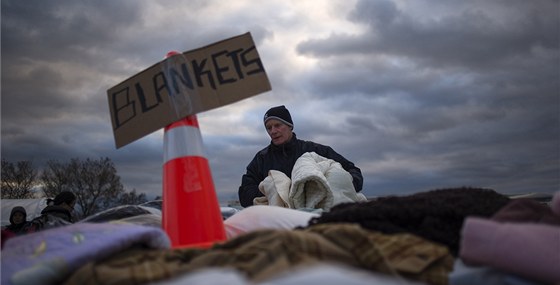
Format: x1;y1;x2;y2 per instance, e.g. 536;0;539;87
107;33;271;148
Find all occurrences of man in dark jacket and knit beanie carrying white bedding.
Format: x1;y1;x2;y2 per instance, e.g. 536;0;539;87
238;105;363;207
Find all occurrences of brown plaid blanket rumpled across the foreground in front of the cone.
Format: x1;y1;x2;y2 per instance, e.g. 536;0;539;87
65;224;454;285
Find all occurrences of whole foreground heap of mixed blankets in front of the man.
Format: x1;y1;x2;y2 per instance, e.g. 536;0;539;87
1;188;560;285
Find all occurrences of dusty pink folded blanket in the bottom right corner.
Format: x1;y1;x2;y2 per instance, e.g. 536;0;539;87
460;217;560;284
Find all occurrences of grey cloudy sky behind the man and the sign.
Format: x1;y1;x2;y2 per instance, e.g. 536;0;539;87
1;0;560;200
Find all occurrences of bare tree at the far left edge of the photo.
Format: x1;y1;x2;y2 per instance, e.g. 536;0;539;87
1;159;37;199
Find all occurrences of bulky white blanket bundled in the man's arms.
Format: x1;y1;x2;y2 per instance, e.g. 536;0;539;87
253;152;367;210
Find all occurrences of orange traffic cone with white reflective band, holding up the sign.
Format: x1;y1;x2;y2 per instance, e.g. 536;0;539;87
162;52;226;248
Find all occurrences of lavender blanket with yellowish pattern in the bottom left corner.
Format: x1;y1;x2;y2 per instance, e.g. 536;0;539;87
2;223;170;285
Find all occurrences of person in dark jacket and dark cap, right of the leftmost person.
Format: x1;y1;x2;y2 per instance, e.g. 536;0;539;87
26;191;76;233
